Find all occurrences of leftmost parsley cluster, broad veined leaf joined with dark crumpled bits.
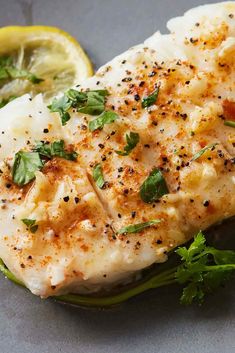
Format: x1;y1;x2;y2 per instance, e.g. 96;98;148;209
12;140;77;186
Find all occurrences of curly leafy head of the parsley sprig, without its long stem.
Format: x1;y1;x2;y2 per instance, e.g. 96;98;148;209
176;232;235;304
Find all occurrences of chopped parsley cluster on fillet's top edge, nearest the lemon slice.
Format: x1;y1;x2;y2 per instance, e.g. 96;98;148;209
48;89;108;126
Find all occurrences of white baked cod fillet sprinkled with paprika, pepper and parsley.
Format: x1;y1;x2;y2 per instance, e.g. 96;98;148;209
0;2;235;297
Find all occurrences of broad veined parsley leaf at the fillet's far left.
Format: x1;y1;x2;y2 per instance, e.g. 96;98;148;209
12;151;44;186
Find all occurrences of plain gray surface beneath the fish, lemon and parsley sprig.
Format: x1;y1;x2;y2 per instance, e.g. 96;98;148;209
0;0;235;353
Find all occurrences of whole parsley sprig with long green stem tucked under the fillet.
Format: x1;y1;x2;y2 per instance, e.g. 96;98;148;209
0;232;235;307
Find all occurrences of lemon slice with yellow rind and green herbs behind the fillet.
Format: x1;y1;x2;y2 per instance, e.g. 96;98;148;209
0;26;93;103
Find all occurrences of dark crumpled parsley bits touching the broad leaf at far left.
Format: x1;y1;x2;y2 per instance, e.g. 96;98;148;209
34;140;78;161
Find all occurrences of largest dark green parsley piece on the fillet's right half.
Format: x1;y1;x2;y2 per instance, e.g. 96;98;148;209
140;168;169;203
